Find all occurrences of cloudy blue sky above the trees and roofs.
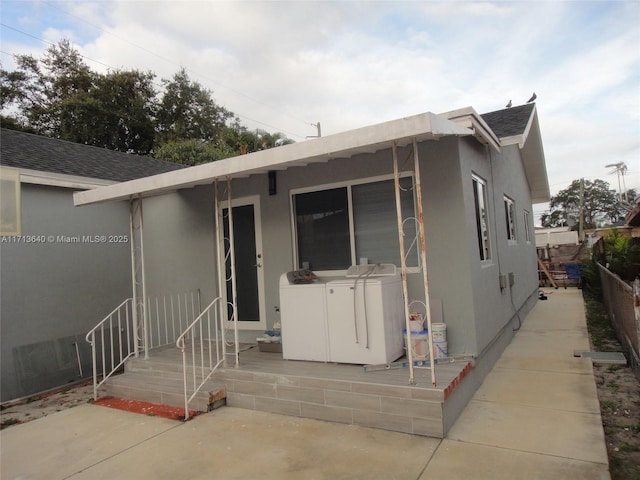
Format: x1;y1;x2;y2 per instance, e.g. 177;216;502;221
0;0;640;221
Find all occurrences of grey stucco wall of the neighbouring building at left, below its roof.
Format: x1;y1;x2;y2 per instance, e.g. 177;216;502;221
0;184;131;401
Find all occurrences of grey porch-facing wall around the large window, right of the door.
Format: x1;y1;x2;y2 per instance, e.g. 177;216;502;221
205;138;482;354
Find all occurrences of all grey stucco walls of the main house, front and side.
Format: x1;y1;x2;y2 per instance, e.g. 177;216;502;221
139;137;537;355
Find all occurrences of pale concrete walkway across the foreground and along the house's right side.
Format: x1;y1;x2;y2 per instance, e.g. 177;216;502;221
0;290;610;480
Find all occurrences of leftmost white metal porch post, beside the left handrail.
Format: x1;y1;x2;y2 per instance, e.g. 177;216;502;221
129;195;149;358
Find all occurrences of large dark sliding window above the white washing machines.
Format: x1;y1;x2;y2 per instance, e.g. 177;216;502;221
293;177;418;271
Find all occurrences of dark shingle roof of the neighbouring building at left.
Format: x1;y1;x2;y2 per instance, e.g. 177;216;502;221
0;128;184;182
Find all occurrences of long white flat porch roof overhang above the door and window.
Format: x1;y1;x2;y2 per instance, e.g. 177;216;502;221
74;112;474;206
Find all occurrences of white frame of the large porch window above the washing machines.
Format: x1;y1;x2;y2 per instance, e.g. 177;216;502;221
289;172;422;277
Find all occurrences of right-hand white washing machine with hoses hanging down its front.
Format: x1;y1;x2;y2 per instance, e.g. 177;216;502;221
328;264;404;364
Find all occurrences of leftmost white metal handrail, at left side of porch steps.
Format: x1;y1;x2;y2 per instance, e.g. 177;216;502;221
85;298;135;400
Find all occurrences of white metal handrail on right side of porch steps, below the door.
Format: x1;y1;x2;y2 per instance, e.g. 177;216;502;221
176;297;224;420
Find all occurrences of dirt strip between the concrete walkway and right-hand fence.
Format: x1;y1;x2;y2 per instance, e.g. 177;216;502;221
585;299;640;480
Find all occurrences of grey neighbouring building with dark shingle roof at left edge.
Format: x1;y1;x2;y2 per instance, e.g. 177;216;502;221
0;129;183;402
